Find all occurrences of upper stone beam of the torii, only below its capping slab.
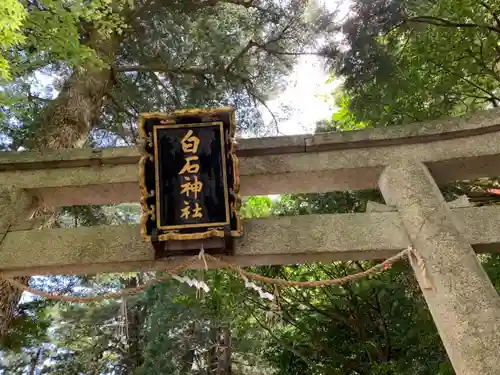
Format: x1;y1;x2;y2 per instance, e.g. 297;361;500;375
0;128;500;206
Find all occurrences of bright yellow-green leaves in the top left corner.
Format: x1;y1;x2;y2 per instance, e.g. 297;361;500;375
15;0;128;75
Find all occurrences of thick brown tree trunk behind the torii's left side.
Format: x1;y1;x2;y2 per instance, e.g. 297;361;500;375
0;30;119;339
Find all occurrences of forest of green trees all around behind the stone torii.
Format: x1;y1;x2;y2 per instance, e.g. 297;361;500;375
0;0;500;375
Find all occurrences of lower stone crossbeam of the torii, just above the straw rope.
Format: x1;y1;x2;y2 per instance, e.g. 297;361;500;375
0;207;500;275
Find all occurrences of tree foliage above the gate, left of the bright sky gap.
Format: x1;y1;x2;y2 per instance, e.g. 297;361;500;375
0;0;336;149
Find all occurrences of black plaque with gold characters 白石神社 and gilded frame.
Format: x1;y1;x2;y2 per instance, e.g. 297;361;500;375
139;108;242;258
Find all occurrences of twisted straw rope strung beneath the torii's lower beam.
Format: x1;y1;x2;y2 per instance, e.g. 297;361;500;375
1;247;431;303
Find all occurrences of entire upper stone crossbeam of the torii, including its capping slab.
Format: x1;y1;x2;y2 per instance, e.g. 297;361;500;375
0;110;500;206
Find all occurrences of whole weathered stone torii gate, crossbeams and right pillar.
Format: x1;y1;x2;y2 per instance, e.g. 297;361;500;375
0;110;500;375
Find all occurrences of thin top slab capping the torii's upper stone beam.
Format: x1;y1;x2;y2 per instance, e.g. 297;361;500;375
0;109;500;171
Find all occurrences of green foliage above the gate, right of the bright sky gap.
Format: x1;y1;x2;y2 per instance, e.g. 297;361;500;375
328;0;500;126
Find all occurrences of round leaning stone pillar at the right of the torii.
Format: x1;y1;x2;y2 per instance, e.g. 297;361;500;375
379;160;500;375
